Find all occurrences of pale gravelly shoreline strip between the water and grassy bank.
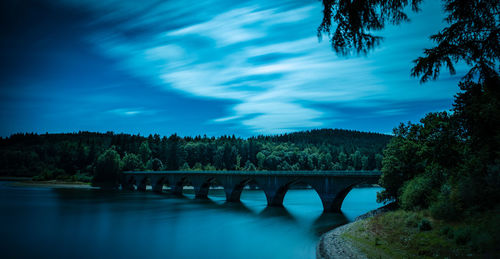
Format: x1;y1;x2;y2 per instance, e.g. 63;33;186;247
316;203;394;259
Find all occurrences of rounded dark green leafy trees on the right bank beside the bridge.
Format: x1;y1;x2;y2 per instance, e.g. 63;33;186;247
377;107;500;217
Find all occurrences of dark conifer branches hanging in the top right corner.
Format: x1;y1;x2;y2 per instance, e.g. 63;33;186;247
412;0;500;83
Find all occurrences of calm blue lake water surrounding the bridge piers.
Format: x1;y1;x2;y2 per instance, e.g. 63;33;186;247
0;182;381;258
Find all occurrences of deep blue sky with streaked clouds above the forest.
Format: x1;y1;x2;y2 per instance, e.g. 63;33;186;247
0;0;465;137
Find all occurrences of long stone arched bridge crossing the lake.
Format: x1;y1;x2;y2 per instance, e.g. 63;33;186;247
121;171;381;212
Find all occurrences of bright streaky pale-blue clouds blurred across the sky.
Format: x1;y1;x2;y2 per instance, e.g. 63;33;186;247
65;0;456;133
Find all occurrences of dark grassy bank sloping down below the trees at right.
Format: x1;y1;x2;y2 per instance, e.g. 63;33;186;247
342;208;500;258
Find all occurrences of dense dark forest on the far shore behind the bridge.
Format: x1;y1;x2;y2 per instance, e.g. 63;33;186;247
0;129;392;182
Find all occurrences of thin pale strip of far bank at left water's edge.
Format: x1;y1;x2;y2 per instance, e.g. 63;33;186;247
0;176;97;189
